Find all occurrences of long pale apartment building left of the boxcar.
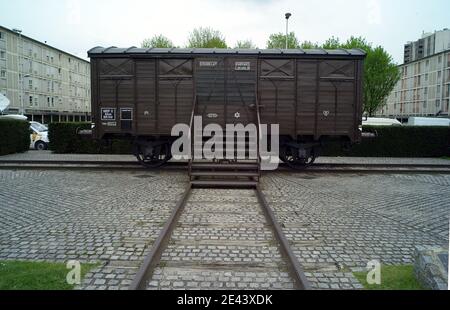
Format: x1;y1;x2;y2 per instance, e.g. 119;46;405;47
0;26;91;123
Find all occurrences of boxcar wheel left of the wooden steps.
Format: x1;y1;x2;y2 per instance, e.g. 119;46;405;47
134;143;172;168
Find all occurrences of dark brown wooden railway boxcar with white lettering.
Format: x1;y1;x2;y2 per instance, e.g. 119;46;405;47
88;47;365;167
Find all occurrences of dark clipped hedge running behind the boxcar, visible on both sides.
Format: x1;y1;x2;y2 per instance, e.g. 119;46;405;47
49;123;450;157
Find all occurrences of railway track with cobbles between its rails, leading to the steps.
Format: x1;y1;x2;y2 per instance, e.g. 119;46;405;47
130;186;310;290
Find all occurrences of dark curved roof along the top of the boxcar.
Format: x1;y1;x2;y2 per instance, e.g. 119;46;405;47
88;46;366;57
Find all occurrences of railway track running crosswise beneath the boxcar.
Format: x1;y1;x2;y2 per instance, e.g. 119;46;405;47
0;160;450;173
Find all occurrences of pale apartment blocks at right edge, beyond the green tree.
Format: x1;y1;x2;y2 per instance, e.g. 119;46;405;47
377;30;450;120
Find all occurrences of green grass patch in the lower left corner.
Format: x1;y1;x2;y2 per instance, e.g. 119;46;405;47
0;261;99;290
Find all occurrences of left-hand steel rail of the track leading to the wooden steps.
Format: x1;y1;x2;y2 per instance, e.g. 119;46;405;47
129;184;192;290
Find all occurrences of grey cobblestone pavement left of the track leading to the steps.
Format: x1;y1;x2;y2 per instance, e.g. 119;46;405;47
0;170;187;289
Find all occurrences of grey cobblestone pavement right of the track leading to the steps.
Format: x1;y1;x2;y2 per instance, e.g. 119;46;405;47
263;174;450;289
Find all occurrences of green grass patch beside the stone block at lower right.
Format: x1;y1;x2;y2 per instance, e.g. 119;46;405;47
353;265;425;290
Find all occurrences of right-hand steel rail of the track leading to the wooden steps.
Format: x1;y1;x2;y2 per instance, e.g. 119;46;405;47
256;185;311;290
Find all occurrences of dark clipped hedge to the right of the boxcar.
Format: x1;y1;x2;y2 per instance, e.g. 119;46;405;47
322;126;450;158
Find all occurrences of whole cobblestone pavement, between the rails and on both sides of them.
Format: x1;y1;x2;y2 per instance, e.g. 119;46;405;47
0;170;450;289
